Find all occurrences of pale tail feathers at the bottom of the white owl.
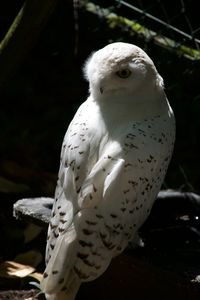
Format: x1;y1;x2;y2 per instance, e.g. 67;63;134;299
40;226;80;300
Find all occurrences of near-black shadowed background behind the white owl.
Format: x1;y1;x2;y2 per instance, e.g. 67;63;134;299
0;0;200;296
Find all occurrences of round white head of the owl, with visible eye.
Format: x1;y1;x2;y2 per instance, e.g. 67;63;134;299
84;42;163;98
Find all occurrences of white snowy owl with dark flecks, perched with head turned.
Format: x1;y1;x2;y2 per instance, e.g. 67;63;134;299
41;43;175;300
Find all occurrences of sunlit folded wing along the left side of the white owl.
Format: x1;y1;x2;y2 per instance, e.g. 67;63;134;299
41;99;114;292
